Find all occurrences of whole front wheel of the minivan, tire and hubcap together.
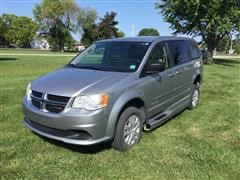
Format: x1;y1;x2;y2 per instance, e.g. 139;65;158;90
112;107;145;151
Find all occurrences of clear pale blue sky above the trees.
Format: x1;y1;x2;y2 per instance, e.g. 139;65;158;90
0;0;197;40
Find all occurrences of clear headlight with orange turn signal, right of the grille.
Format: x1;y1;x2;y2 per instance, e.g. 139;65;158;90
72;94;108;111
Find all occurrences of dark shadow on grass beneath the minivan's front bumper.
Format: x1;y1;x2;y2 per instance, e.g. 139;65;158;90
33;132;111;154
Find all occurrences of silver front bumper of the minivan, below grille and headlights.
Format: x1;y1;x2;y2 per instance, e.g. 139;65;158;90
22;98;112;145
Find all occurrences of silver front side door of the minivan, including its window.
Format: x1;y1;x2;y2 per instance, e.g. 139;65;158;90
142;42;176;117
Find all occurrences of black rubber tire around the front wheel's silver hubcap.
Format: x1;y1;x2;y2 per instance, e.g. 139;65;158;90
112;107;145;151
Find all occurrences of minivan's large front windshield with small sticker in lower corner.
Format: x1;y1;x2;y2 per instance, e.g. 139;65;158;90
69;41;150;72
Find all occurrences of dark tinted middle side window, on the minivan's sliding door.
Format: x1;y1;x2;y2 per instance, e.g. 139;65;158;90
168;41;190;65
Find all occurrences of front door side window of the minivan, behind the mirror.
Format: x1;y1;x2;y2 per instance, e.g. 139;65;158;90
147;43;169;69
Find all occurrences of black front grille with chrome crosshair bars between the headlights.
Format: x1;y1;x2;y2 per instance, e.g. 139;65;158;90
30;91;70;113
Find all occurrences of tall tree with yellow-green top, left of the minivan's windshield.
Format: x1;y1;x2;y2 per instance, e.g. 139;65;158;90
33;0;78;51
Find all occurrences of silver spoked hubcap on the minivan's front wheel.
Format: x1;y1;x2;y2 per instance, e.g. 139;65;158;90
123;115;140;145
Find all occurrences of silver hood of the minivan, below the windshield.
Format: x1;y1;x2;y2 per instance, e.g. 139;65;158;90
31;68;128;97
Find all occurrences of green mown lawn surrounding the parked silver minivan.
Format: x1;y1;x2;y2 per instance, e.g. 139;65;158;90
0;52;240;179
